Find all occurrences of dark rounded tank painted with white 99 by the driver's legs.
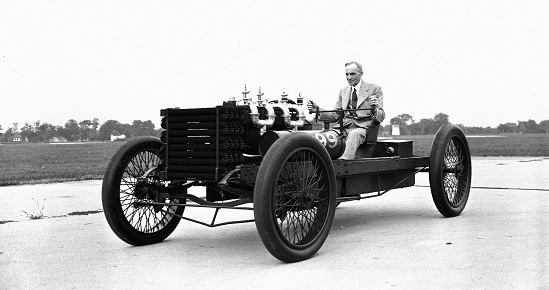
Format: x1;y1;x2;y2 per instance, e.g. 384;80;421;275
259;130;345;159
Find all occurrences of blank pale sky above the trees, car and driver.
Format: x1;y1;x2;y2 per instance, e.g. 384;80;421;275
0;0;549;130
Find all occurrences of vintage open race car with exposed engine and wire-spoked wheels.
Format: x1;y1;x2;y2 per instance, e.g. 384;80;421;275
102;91;471;262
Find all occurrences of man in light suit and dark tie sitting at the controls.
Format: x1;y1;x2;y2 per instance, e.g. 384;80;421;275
307;61;385;159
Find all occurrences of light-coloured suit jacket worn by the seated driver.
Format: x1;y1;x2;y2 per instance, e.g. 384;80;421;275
319;80;385;128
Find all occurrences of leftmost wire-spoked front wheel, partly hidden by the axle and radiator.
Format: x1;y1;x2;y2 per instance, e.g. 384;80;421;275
102;137;185;246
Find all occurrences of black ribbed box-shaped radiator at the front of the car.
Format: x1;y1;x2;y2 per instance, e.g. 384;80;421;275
160;106;249;181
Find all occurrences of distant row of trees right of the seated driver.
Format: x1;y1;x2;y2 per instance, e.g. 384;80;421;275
383;113;549;135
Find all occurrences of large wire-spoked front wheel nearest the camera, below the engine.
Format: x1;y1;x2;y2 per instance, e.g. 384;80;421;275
254;133;336;263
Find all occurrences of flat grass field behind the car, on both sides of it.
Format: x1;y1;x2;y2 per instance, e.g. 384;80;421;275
0;134;549;186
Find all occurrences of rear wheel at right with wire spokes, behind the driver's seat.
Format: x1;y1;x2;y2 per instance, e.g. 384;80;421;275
429;124;472;217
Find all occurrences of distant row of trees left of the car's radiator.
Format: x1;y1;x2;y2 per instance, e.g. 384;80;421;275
0;118;160;143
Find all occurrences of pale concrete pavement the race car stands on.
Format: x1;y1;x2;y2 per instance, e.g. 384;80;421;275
0;158;549;289
